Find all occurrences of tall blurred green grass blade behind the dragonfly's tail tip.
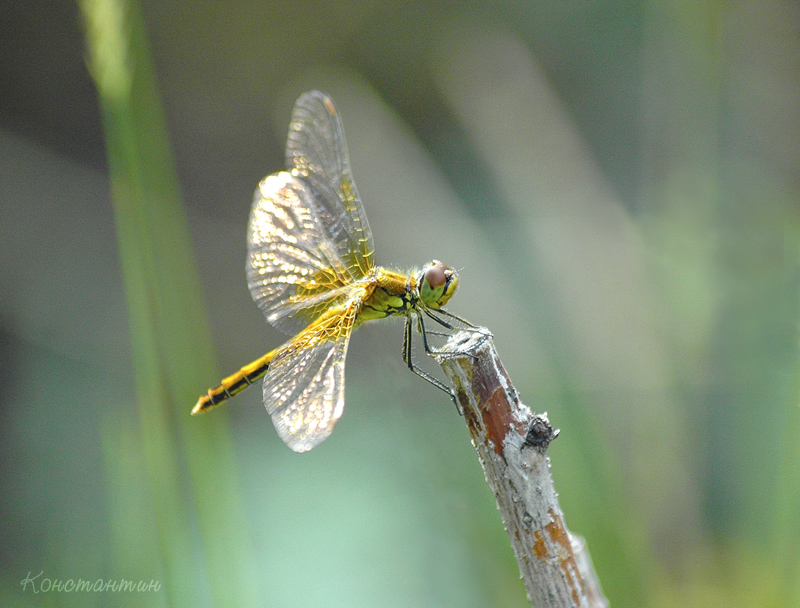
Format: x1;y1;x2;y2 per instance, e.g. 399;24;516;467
81;0;257;606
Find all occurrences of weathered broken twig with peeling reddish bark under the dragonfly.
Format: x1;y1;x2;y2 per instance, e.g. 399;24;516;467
437;330;608;608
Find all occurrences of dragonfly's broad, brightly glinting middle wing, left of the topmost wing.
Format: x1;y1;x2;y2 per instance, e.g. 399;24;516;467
247;171;354;334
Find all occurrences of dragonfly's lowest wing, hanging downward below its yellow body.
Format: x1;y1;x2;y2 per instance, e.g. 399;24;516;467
264;297;361;452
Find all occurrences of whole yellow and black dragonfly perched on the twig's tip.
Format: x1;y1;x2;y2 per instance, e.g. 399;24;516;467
192;91;474;452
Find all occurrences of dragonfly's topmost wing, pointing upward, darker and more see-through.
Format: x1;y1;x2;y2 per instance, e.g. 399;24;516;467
286;91;374;278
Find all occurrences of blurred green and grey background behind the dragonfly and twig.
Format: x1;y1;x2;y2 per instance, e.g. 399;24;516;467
0;0;800;608
